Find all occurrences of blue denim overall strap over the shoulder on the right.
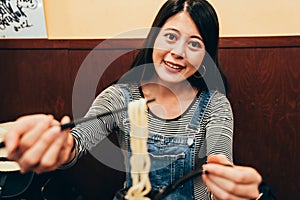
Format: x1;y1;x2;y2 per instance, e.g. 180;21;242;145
186;91;216;132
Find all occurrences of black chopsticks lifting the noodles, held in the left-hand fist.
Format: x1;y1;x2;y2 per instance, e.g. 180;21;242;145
0;99;155;148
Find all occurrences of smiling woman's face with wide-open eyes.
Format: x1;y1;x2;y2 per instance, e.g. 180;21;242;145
152;12;205;83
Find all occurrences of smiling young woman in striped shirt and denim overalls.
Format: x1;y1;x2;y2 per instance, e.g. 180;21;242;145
5;0;274;199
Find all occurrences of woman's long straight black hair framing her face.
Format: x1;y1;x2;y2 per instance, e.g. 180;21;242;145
123;0;227;92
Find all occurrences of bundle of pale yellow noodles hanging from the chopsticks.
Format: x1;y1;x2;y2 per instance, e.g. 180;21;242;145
125;98;151;200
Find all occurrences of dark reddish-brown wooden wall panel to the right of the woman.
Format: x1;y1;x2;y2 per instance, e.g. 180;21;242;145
220;47;300;199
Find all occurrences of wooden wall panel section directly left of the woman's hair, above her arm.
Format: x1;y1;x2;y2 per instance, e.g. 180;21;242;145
69;49;134;118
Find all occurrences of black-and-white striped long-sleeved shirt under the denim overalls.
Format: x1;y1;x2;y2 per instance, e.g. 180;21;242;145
71;84;233;200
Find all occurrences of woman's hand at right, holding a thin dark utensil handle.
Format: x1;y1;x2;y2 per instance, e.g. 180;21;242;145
202;155;262;200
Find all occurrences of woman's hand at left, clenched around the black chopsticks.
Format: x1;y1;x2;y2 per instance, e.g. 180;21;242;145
4;114;75;173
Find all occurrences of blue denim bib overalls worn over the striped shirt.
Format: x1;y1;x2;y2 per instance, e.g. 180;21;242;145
116;85;212;200
